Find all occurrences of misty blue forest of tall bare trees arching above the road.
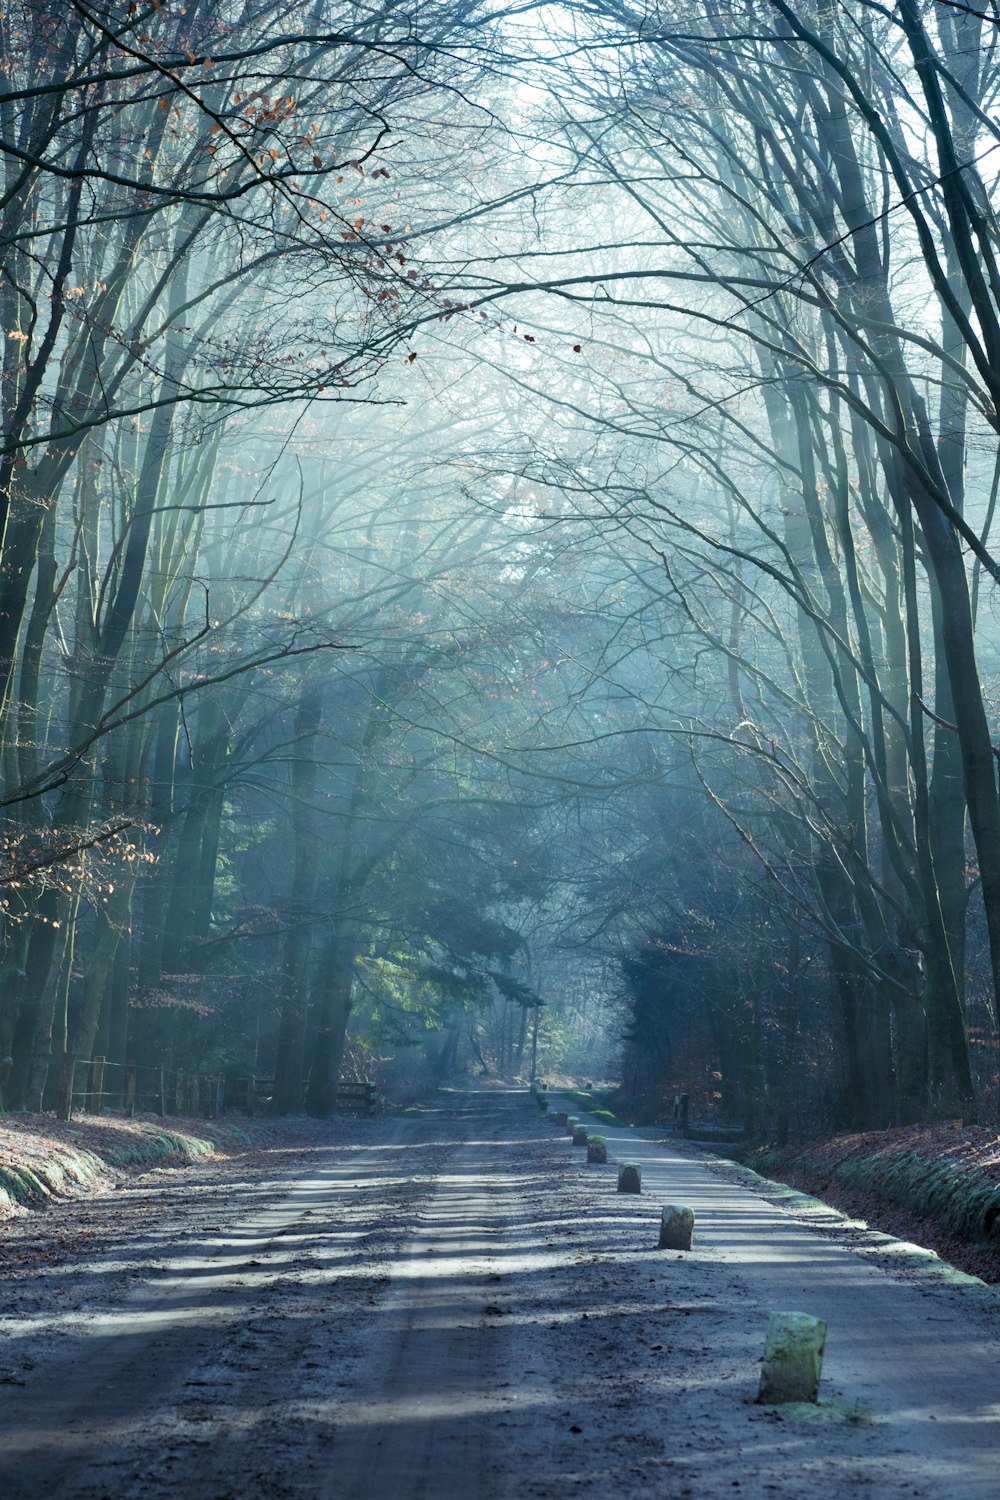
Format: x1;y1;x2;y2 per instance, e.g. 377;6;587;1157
0;0;1000;1140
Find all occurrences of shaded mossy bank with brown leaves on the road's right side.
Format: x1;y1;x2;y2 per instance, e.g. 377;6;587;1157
726;1124;1000;1284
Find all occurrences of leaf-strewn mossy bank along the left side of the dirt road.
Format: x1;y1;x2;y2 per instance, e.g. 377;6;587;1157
0;1115;305;1220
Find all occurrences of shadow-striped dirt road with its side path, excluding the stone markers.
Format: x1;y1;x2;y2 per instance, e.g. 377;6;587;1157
0;1088;1000;1500
